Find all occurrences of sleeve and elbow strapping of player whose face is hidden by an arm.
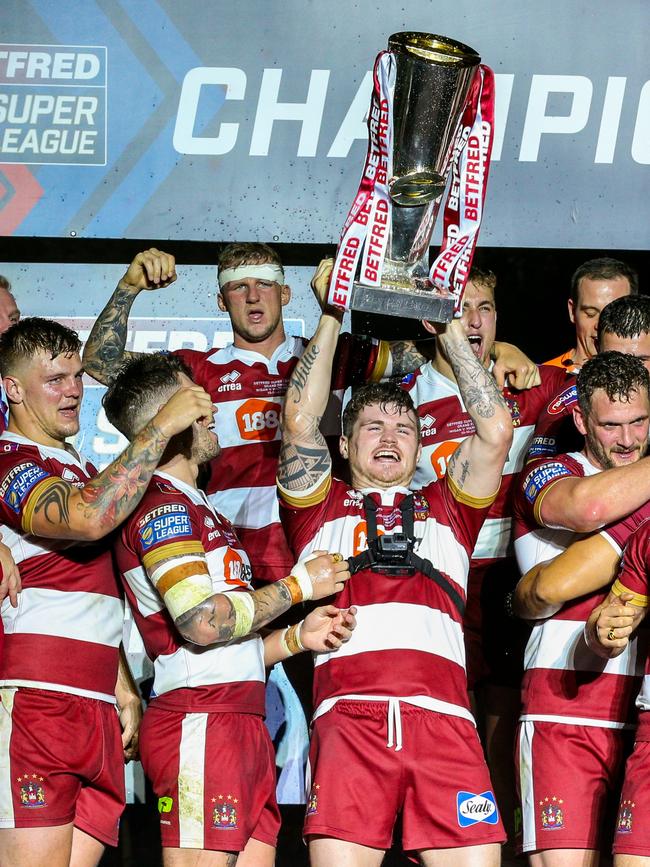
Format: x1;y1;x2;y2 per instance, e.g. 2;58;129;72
127;497;214;620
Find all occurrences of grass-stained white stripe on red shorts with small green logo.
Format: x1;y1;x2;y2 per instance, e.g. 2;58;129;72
178;713;208;849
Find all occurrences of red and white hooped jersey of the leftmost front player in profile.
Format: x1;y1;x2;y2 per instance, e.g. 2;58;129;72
0;431;124;703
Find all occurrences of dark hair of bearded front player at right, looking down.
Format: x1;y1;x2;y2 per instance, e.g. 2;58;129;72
576;352;650;416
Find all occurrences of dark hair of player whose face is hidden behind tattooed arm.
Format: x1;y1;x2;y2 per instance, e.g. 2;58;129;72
102;353;192;440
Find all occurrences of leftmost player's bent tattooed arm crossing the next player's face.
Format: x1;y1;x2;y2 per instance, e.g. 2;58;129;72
22;386;213;541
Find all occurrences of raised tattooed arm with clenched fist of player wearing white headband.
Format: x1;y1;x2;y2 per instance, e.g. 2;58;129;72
83;247;176;385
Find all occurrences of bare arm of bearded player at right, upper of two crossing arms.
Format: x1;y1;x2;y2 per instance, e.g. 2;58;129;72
537;458;650;533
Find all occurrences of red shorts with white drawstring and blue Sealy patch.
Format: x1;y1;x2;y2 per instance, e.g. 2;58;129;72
305;700;505;851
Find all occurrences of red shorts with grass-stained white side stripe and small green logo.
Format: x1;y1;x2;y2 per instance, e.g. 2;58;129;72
140;703;280;852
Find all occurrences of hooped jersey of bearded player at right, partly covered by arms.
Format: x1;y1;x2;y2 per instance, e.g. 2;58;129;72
515;452;643;728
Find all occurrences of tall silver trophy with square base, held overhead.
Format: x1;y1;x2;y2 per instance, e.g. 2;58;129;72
350;32;481;322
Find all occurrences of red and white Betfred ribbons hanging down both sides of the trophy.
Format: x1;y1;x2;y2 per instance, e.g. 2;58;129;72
327;51;494;315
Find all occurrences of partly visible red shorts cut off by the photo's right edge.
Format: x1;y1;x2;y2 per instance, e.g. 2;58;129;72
614;740;650;858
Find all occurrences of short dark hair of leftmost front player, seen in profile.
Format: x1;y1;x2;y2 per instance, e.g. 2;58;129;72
0;316;81;375
